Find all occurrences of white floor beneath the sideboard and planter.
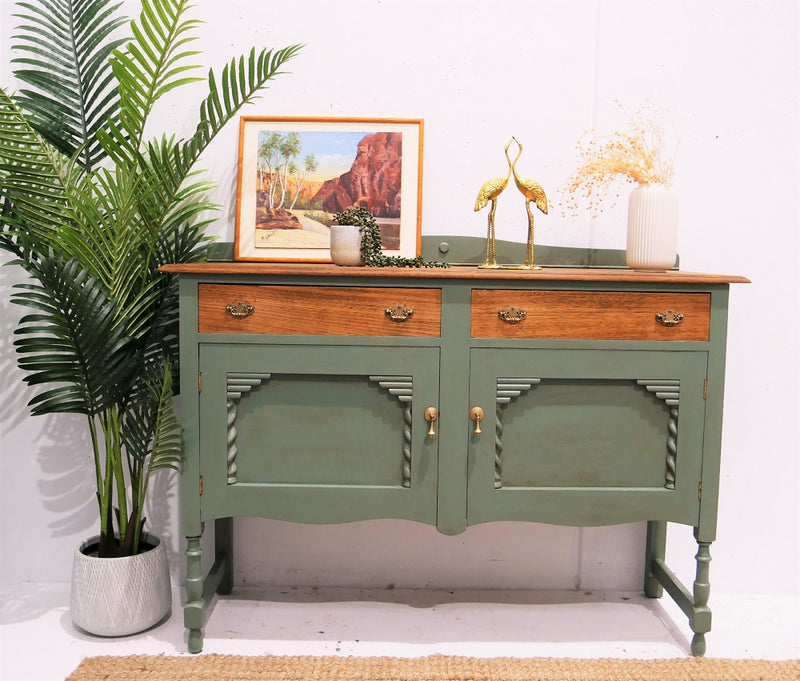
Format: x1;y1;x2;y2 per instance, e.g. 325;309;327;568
0;584;800;681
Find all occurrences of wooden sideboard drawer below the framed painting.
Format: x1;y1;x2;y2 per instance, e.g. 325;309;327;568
198;284;442;337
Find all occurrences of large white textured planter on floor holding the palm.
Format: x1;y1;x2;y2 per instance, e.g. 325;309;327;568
70;533;172;636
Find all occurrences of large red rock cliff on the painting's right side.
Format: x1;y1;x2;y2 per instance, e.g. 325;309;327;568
314;132;403;218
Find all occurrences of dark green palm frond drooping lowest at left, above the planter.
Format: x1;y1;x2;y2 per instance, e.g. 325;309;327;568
11;255;137;416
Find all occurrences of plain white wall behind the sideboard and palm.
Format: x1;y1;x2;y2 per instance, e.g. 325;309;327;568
0;0;800;594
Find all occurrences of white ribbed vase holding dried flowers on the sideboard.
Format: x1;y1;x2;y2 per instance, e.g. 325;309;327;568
626;184;678;270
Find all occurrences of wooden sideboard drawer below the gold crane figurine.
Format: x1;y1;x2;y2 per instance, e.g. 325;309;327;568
470;289;711;341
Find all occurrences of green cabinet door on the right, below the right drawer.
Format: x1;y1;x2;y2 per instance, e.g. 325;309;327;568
467;348;706;525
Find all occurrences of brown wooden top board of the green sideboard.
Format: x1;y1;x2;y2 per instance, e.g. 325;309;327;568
161;262;750;284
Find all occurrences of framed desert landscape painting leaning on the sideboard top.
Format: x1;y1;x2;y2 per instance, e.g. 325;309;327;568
234;116;423;262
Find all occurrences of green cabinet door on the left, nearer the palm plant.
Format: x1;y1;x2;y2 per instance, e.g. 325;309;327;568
200;344;439;523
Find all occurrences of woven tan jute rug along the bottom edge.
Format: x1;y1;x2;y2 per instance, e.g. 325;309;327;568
66;655;800;681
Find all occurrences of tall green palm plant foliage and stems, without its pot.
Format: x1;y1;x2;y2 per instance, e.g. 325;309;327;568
0;0;299;556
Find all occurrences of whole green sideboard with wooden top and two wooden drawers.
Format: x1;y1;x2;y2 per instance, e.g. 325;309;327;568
164;237;747;655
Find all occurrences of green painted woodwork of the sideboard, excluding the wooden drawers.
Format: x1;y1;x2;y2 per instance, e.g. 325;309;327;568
172;237;740;654
